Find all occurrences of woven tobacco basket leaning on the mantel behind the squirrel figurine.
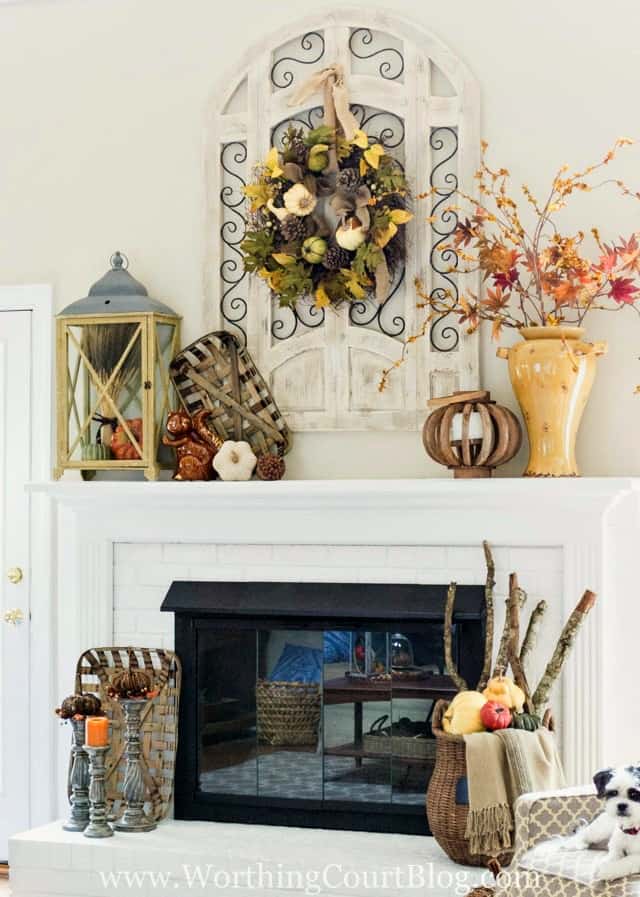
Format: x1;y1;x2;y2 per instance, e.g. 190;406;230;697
169;330;291;455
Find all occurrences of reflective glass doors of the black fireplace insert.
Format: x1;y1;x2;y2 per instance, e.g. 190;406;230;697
197;624;449;812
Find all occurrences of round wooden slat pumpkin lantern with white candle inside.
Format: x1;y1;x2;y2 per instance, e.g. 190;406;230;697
422;390;522;479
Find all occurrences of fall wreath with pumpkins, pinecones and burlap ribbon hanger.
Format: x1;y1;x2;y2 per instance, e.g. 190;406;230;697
242;66;413;308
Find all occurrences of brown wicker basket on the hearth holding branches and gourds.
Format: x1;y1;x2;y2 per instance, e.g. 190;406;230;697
427;701;513;866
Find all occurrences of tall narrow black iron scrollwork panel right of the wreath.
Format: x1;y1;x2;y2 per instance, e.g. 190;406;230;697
429;127;460;352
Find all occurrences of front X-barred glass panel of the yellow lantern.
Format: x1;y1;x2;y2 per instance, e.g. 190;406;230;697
67;321;144;462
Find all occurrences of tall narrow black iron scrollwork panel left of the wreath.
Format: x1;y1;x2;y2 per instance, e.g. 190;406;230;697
220;140;248;343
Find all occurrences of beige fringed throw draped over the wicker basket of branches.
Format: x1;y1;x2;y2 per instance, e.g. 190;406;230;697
464;729;565;856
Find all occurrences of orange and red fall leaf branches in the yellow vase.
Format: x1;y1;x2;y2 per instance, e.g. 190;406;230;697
379;137;640;391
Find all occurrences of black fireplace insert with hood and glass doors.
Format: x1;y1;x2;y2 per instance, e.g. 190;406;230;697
162;582;485;835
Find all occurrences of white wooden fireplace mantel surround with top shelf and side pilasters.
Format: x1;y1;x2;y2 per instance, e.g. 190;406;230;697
29;478;640;804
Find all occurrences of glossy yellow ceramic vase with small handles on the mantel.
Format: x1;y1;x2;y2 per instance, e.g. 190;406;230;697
498;327;607;477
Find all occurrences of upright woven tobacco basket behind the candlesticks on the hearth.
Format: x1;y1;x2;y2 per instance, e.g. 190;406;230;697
75;648;181;821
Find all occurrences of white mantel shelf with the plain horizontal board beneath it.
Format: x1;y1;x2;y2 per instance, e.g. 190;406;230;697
28;477;640;545
